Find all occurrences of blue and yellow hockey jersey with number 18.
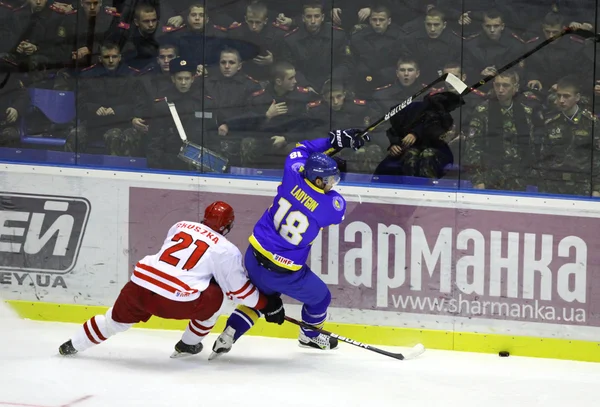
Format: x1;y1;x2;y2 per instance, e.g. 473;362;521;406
249;138;346;271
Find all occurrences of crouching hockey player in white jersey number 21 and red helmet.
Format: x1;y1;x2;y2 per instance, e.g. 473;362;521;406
59;201;285;357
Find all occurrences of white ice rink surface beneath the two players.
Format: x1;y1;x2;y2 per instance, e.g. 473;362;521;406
0;308;600;407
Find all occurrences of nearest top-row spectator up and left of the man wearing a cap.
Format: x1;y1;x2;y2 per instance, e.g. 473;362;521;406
109;3;160;69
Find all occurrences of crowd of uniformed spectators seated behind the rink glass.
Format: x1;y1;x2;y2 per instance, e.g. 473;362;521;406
0;0;600;196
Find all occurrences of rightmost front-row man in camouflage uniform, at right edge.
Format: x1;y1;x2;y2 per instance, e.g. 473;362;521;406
539;77;600;196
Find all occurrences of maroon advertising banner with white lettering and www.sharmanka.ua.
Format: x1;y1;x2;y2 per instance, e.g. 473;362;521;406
129;188;600;332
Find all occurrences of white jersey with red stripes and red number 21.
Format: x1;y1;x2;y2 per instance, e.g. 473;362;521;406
131;221;266;309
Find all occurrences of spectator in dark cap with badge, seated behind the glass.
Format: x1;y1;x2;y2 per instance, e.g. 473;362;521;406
147;57;218;171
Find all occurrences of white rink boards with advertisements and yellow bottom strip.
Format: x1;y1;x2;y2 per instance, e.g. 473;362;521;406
0;165;600;361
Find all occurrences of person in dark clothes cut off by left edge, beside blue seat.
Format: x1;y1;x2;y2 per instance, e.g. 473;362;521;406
0;75;29;148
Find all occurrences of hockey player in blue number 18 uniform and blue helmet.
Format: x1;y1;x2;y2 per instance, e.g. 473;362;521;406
209;129;370;360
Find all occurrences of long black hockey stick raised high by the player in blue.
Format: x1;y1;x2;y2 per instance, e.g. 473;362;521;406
325;27;600;156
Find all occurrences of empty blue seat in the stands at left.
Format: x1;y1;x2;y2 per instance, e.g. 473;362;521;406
21;88;77;147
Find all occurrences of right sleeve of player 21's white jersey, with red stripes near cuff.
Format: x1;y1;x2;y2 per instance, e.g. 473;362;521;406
213;250;267;310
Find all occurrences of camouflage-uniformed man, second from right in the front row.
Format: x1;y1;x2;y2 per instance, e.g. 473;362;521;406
464;70;543;191
